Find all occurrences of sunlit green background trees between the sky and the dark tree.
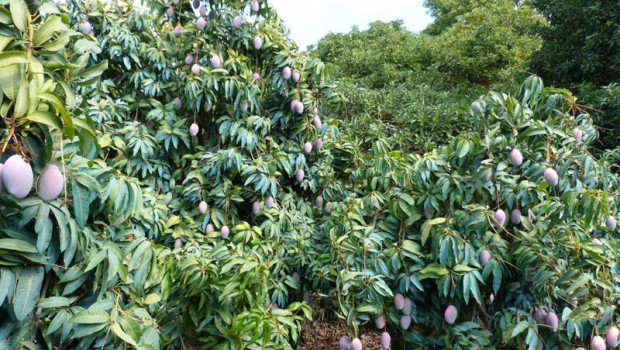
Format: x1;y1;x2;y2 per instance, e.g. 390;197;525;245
311;0;542;152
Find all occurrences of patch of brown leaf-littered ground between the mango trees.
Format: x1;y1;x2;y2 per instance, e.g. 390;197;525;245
297;321;382;350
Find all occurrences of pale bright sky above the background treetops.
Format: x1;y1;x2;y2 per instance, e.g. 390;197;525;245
269;0;432;49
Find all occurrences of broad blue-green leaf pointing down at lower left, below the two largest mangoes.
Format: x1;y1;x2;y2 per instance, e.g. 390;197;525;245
13;267;44;321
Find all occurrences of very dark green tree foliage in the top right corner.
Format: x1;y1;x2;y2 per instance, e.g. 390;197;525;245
530;0;620;86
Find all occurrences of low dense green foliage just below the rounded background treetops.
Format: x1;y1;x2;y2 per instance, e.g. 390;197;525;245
324;79;482;152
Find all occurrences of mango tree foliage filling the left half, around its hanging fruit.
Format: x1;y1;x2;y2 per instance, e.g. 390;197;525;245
0;0;330;349
